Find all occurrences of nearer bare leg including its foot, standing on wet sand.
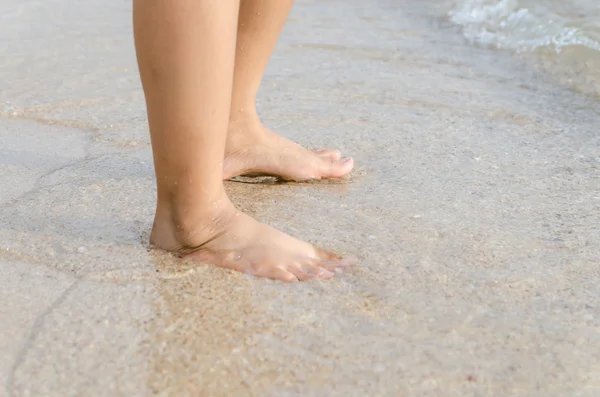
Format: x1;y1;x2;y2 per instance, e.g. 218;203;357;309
134;0;346;281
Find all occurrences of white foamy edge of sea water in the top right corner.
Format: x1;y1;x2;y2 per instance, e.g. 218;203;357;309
422;0;600;101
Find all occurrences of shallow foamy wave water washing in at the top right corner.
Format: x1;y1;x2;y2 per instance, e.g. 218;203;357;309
428;0;600;96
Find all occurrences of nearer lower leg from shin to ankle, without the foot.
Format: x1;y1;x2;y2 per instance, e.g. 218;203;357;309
134;0;238;241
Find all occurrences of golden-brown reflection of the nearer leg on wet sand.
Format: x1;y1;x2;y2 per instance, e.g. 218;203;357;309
147;258;285;396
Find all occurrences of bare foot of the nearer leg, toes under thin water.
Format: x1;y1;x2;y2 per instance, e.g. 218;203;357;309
150;199;350;282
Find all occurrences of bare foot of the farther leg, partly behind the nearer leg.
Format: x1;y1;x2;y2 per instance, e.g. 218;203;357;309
223;117;354;181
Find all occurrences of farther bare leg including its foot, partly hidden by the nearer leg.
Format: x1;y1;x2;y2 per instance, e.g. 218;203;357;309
224;0;353;180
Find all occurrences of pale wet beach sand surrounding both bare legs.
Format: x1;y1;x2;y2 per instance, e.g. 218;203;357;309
0;0;600;397
